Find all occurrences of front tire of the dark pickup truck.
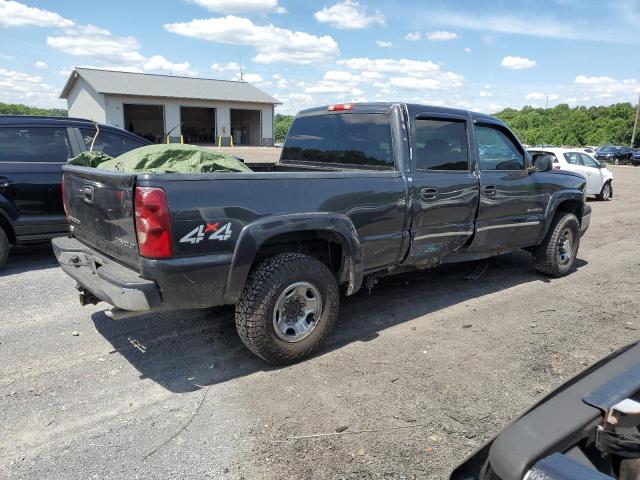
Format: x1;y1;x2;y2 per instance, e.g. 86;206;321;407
533;212;580;277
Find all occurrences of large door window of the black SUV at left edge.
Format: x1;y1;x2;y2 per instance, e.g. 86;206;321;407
0;127;73;163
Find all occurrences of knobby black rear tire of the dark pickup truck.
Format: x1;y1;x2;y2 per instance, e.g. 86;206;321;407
235;253;340;365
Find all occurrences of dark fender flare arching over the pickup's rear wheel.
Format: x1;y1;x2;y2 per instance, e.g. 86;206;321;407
224;213;364;303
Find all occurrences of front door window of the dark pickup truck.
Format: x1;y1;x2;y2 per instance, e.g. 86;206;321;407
476;126;524;171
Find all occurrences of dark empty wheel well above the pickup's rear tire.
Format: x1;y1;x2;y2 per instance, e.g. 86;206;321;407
251;230;349;283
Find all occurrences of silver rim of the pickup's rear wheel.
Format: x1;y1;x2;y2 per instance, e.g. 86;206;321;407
273;282;322;343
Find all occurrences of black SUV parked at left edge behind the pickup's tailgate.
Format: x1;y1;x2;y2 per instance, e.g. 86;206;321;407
0;115;149;267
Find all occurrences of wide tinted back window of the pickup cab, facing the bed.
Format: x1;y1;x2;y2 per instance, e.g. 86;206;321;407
282;113;393;170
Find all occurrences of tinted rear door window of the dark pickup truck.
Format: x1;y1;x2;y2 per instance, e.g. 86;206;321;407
413;119;469;170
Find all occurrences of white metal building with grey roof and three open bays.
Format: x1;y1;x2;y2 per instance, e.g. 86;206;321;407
60;68;280;146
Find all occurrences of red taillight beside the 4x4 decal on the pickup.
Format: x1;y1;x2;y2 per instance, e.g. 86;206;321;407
135;187;173;258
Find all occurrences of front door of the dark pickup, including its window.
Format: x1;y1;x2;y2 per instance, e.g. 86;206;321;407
470;120;547;253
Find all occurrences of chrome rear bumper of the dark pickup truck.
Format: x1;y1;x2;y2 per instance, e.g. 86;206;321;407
51;237;162;311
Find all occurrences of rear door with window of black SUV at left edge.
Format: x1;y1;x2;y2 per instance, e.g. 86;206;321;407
0;125;79;241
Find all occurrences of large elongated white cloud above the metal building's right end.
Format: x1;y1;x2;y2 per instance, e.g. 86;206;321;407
164;15;340;64
